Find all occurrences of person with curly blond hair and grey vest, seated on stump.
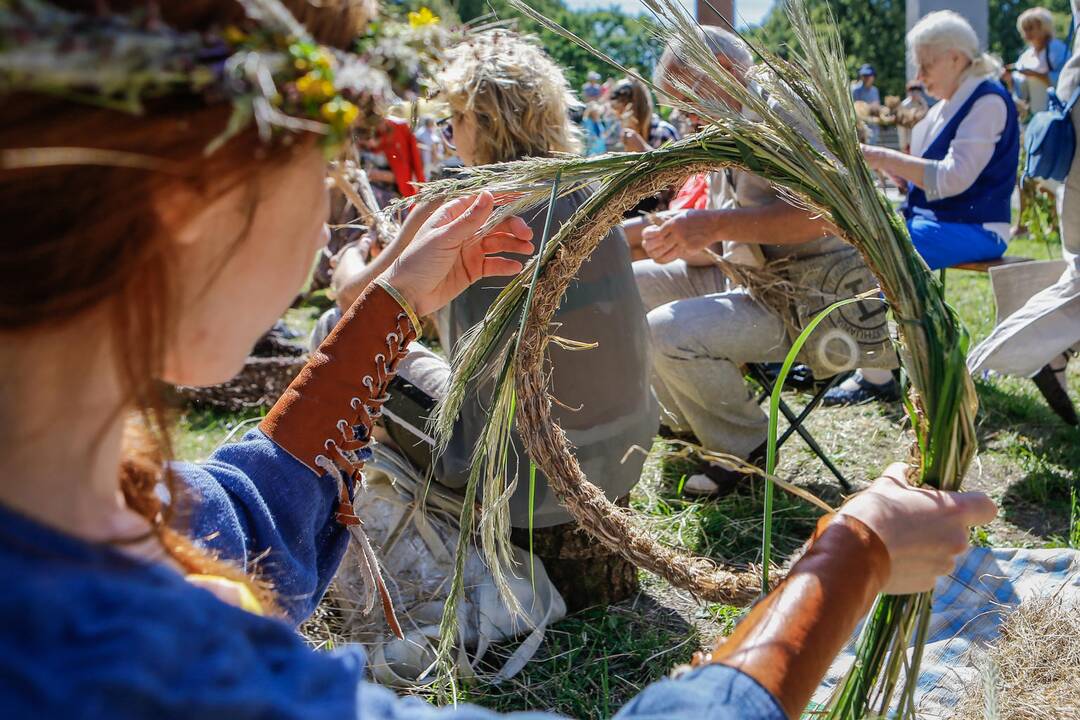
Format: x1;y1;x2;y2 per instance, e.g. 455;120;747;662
371;30;659;611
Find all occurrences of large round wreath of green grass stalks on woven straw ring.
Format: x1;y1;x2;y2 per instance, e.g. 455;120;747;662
412;0;977;718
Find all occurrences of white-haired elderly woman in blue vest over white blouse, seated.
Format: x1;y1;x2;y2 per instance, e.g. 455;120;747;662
863;10;1020;269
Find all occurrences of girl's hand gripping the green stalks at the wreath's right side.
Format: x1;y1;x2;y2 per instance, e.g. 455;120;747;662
838;463;998;595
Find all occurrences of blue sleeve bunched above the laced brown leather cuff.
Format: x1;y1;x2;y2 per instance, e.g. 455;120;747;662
173;430;348;623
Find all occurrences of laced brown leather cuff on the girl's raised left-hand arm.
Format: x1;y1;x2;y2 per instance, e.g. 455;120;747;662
259;284;416;479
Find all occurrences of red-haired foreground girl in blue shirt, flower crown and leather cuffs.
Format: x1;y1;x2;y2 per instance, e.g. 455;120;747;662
0;0;995;720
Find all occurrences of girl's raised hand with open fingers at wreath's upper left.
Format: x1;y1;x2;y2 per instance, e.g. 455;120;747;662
382;191;532;316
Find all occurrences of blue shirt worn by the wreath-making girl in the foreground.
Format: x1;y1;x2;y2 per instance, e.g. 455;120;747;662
0;431;785;720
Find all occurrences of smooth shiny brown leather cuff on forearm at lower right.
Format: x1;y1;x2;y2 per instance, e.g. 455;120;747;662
712;515;890;718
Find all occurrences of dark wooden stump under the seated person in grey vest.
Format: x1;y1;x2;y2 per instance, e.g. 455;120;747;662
510;495;638;612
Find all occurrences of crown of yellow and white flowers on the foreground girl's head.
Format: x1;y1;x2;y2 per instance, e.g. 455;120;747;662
0;0;394;155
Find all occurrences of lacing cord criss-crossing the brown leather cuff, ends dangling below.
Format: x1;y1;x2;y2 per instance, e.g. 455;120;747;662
314;312;416;638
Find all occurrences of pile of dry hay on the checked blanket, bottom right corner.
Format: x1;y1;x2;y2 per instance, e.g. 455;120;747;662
955;598;1080;720
